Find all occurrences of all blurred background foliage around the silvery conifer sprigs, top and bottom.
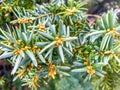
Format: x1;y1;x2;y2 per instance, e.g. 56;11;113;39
0;0;120;90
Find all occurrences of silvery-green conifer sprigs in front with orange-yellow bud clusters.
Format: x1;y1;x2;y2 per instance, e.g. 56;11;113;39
0;0;120;90
